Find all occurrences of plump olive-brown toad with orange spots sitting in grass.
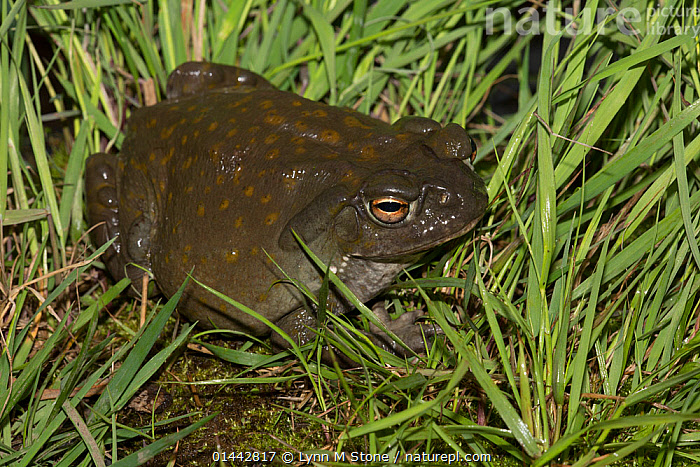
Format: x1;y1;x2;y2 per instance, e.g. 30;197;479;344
86;63;487;354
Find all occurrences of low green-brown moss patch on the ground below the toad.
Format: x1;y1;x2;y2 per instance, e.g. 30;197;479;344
120;342;326;466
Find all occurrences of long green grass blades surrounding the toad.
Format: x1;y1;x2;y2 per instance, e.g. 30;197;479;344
0;0;700;466
